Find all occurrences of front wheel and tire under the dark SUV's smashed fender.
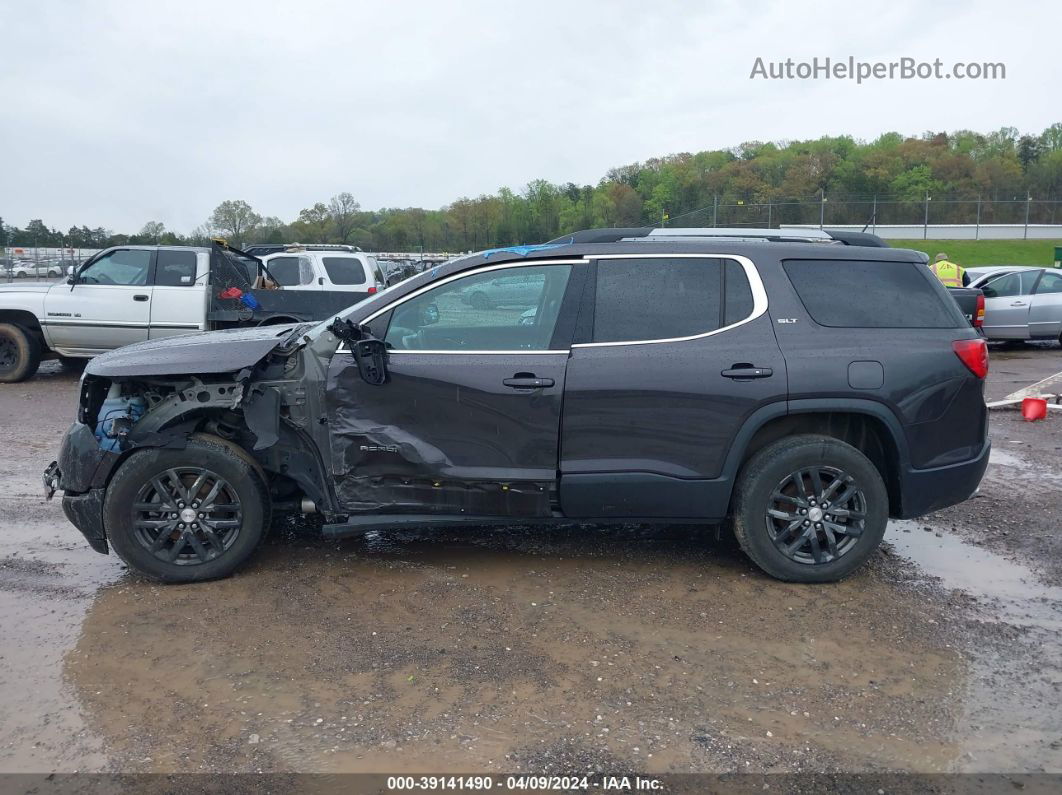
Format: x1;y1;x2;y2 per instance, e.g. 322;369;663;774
103;438;271;583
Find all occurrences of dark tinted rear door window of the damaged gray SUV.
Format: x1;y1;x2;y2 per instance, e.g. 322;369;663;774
594;257;726;343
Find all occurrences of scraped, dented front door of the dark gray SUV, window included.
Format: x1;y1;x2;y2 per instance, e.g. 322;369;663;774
327;262;586;516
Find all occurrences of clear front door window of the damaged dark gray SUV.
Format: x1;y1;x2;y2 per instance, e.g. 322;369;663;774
386;264;571;351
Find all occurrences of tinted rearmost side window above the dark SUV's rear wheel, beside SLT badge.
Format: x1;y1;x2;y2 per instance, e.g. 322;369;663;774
784;259;965;328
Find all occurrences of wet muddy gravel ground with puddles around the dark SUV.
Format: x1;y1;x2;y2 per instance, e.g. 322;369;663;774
0;346;1062;773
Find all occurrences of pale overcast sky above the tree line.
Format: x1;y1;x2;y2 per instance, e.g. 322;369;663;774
0;0;1062;231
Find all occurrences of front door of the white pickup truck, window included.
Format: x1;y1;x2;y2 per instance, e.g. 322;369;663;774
42;248;155;356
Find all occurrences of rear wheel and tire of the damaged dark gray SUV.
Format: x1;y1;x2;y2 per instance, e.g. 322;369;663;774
733;435;889;583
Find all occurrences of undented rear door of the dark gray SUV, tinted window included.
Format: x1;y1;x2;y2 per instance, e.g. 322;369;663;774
561;255;786;518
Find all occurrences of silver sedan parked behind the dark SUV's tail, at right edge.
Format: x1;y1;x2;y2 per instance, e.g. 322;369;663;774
970;267;1062;343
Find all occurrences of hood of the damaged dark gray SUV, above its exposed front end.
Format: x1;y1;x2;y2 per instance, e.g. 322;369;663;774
85;324;296;378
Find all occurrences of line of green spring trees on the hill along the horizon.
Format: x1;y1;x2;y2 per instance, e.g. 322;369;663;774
0;123;1062;252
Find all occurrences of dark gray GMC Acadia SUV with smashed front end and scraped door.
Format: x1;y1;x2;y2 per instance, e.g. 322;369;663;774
45;228;989;583
